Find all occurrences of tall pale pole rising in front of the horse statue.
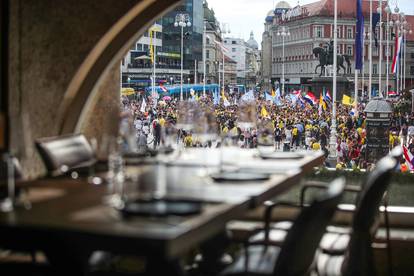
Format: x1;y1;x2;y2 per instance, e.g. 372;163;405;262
329;0;338;159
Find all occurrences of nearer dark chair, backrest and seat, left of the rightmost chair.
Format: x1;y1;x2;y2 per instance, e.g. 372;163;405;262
222;178;345;276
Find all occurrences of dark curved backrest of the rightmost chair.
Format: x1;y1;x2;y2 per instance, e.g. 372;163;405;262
343;154;397;275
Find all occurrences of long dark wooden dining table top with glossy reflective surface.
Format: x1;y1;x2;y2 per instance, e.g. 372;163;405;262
0;149;324;259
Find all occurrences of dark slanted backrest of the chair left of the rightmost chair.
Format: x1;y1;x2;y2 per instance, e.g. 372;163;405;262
274;178;345;276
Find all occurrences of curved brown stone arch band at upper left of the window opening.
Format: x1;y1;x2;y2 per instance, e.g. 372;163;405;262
57;0;181;134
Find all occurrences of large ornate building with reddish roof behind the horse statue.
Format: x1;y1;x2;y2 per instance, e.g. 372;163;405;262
263;0;412;94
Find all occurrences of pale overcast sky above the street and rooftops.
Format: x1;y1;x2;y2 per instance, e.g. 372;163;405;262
207;0;414;48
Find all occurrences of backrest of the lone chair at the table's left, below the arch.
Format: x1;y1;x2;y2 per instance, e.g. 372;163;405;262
35;134;94;173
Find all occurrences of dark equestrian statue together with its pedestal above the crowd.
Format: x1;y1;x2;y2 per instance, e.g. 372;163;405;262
311;41;354;101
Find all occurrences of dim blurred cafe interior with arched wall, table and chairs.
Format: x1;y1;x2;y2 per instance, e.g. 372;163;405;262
0;0;414;276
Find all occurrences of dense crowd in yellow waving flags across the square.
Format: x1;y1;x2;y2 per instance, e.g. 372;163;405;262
122;88;414;169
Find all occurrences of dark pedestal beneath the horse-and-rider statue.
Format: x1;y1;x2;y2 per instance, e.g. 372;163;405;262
311;76;354;101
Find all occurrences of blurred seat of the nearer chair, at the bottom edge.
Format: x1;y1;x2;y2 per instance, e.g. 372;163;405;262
221;245;280;276
